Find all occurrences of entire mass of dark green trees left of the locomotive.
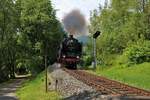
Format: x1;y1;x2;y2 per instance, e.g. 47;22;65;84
0;0;64;82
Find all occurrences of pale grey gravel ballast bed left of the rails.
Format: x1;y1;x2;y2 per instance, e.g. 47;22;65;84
48;63;102;100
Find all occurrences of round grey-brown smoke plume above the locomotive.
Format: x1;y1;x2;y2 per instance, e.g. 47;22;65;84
62;10;87;35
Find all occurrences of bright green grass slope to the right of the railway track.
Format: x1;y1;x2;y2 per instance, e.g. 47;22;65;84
89;63;150;90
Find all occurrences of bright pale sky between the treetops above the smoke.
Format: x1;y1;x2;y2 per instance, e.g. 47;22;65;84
52;0;105;22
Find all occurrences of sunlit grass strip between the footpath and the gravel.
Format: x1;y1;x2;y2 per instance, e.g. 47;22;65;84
17;72;61;100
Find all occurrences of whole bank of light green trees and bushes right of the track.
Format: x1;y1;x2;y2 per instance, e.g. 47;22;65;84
90;0;150;66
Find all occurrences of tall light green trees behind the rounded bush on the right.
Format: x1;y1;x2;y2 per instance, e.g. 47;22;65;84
90;0;150;63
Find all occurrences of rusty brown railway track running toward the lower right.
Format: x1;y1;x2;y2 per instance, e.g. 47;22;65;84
63;68;150;97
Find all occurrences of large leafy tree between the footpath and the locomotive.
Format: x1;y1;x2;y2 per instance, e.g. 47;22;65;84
18;0;64;74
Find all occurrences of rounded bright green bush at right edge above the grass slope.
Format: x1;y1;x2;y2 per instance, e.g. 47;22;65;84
124;41;150;64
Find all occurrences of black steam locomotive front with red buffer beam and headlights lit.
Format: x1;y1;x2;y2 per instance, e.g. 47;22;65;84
58;35;82;69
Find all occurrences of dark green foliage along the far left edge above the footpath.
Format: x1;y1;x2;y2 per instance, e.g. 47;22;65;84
0;0;17;82
